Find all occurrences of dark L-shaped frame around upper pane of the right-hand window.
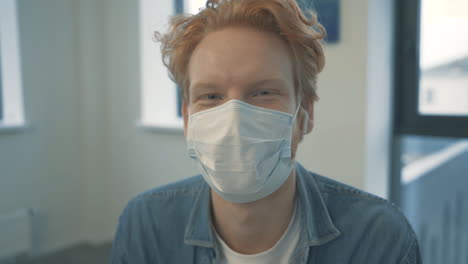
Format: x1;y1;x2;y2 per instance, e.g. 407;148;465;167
394;0;468;138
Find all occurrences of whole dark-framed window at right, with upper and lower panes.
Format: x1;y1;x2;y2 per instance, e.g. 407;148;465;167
391;0;468;264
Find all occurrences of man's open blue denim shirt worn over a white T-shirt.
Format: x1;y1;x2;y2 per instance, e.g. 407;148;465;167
110;163;421;264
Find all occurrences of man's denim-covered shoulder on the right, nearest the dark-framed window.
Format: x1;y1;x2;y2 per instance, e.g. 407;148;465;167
304;169;419;263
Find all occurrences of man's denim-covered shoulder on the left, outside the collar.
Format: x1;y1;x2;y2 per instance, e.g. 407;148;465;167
111;176;203;263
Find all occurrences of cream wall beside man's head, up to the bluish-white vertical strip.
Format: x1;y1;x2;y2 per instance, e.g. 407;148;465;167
298;0;368;188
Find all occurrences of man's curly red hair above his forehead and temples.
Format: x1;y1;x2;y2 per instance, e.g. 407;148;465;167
155;0;326;100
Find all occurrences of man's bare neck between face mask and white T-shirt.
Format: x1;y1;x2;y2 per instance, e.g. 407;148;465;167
211;170;296;254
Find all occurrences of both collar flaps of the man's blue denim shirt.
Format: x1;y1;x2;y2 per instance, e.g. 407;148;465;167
184;162;340;248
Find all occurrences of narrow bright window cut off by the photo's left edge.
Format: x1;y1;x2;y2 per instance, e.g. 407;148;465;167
0;0;24;128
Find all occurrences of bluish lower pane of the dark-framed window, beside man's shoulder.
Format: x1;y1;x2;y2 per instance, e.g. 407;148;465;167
400;135;468;264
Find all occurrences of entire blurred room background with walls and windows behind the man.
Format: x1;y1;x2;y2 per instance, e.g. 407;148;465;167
0;0;468;264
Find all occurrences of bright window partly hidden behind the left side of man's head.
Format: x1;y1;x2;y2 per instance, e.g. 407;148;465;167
140;0;182;131
